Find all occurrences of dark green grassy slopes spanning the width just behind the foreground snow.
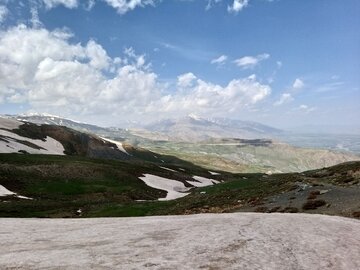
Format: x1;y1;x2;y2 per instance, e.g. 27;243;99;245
0;152;360;217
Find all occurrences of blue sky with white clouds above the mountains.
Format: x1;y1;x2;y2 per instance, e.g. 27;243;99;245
0;0;360;128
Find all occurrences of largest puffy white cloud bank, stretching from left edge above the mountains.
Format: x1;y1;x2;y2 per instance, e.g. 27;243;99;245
0;25;271;123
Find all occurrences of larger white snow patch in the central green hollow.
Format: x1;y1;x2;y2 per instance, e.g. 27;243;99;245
139;174;190;201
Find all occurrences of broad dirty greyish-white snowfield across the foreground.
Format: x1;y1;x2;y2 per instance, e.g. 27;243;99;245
0;213;360;270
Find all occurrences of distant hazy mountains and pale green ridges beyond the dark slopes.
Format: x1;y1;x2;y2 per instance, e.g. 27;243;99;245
1;114;360;173
